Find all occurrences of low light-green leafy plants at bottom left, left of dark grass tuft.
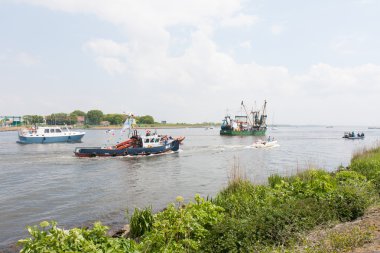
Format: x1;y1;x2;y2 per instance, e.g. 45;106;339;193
19;221;136;253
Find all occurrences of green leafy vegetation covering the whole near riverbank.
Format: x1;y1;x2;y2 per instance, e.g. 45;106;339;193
20;148;380;252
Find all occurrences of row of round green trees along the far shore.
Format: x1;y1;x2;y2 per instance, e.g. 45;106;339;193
23;110;155;125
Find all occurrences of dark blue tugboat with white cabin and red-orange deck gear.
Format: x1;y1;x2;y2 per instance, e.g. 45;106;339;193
74;131;184;157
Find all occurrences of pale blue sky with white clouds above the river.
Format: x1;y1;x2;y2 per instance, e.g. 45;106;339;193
0;0;380;126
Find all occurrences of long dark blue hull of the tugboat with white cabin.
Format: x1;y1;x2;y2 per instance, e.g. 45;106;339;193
74;140;179;157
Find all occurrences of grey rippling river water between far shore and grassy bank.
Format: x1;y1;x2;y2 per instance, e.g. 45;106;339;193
0;127;380;249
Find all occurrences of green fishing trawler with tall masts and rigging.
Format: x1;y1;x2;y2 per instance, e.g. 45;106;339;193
220;100;267;136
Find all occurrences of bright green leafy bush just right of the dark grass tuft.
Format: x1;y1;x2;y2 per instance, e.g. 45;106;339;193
140;194;224;252
